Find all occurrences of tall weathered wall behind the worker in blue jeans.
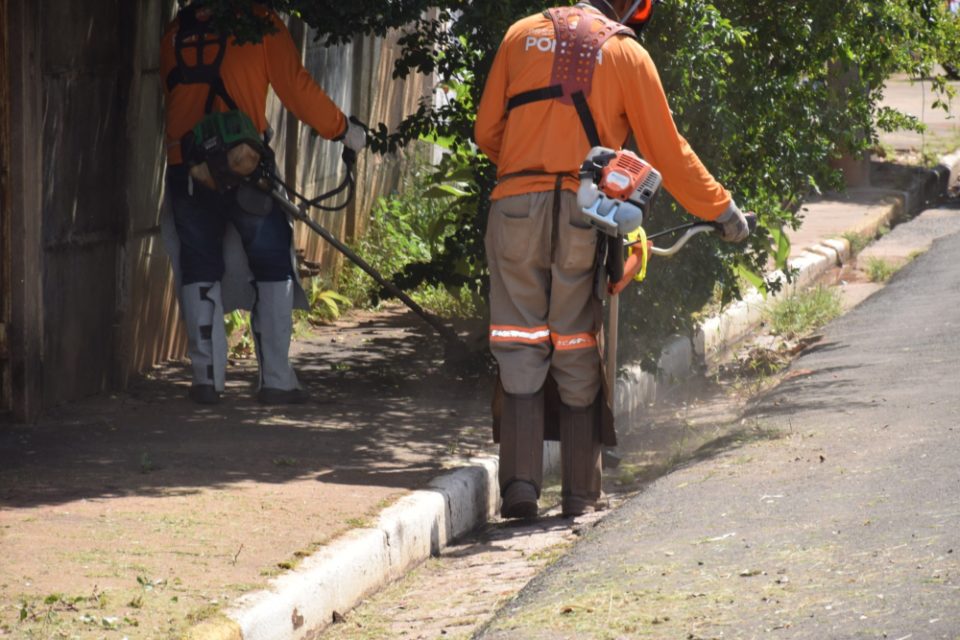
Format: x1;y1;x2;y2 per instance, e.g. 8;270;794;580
0;0;430;421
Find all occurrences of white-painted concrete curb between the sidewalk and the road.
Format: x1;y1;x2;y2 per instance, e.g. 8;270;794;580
186;154;960;640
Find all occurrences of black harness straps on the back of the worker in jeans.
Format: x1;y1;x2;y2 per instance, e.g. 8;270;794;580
167;7;237;113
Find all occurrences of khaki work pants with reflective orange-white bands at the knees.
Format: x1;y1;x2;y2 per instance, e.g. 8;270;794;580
485;186;602;407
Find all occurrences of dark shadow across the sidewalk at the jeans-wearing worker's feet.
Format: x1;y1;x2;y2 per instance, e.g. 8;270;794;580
0;311;490;507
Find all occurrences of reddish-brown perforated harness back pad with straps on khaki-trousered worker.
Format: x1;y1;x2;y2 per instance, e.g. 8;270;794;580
507;7;636;147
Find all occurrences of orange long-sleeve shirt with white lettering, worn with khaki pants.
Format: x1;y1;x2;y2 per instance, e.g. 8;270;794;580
474;7;731;220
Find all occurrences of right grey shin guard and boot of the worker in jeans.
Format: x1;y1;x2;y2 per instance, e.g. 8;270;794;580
250;280;307;404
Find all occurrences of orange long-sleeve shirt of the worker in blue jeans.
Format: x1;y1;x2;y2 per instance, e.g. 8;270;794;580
160;9;347;164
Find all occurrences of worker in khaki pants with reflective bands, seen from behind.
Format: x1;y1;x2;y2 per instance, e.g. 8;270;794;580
475;0;749;518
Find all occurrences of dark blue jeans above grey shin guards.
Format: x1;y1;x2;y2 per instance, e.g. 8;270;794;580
167;165;294;285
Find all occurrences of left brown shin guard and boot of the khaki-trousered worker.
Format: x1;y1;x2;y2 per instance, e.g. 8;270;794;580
499;389;543;519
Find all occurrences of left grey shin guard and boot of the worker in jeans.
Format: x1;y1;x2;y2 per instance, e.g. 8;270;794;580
180;282;227;404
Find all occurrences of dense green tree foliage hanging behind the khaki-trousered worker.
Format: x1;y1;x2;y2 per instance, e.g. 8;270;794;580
189;0;960;358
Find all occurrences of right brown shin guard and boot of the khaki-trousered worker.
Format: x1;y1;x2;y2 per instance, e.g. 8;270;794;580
558;402;601;517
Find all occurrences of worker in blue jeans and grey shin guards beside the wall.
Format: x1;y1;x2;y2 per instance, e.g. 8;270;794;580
160;0;366;404
